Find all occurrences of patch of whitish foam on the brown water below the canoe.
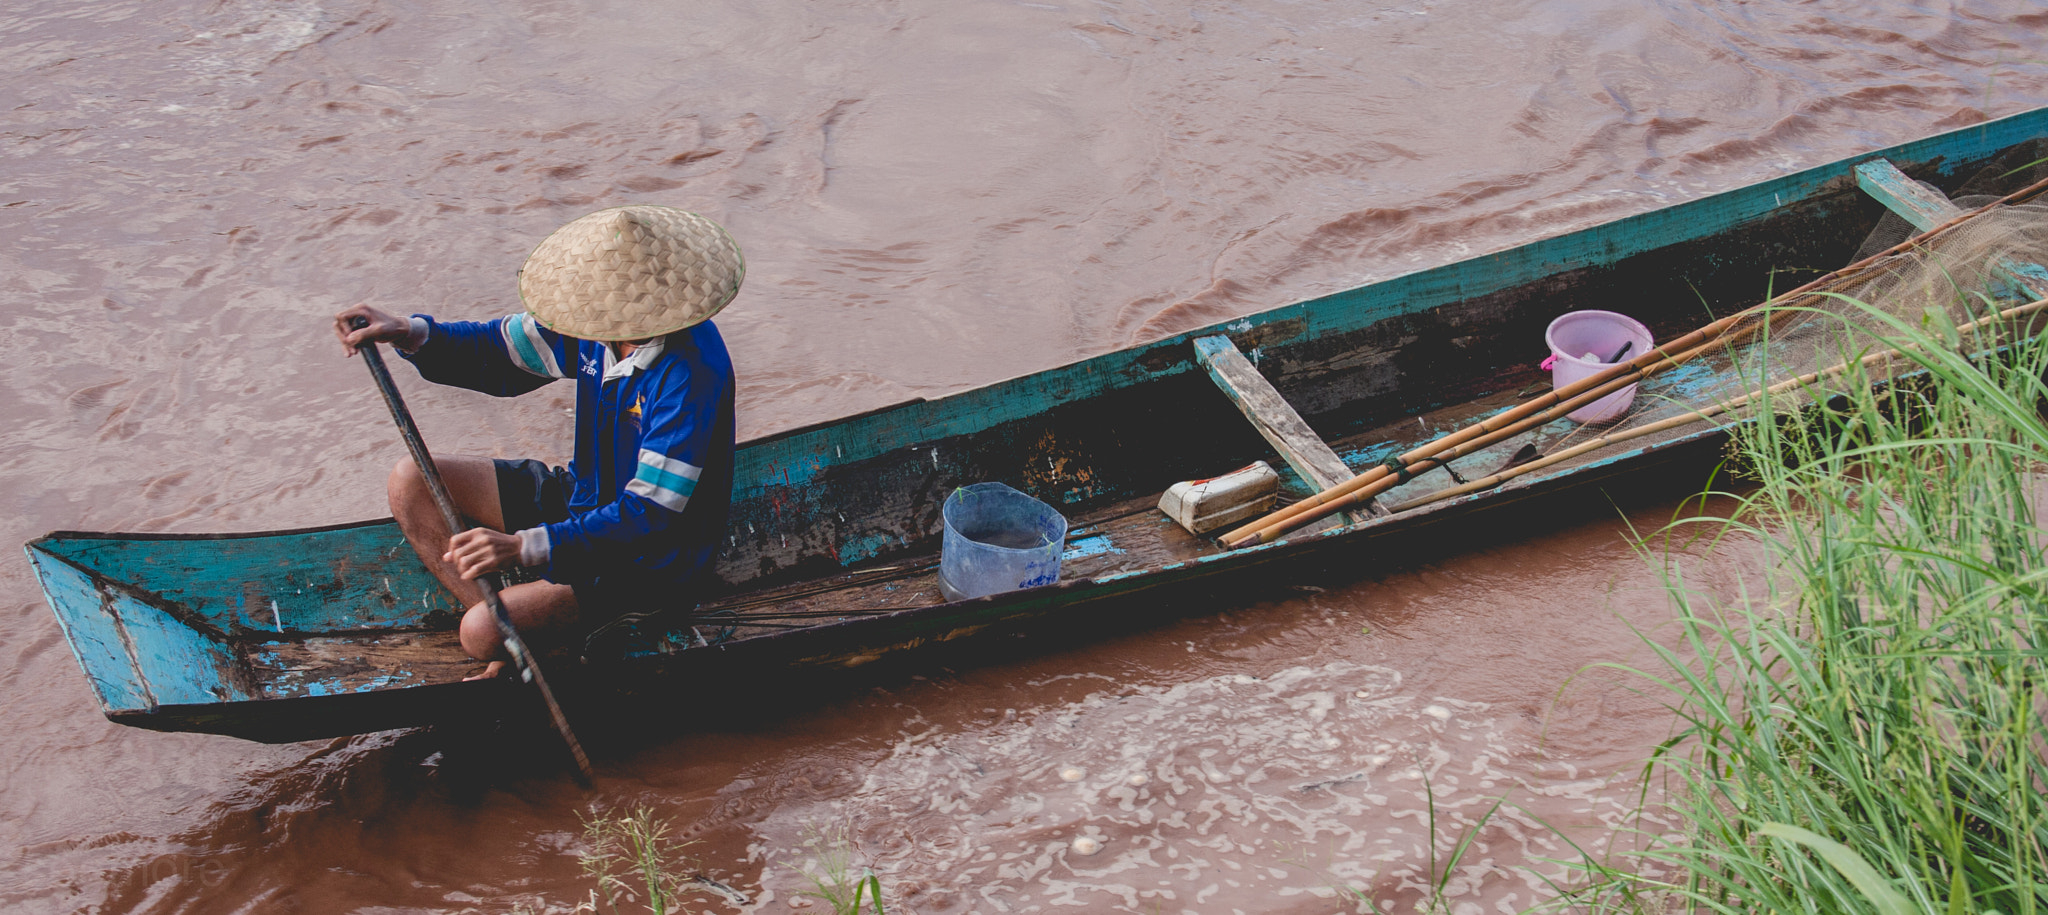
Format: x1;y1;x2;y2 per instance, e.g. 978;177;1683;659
754;661;1671;913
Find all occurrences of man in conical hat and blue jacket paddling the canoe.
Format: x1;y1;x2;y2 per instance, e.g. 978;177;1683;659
334;207;745;676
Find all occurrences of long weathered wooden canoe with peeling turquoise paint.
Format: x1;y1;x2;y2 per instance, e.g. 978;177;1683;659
27;108;2048;741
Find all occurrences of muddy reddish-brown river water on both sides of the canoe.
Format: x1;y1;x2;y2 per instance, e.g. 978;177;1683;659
0;0;2048;915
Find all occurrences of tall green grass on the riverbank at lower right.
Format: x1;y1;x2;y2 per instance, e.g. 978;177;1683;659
1559;296;2048;915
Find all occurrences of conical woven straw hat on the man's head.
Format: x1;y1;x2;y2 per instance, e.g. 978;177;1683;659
518;207;748;340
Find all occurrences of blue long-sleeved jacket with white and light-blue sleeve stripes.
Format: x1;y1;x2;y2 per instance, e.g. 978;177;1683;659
406;313;733;590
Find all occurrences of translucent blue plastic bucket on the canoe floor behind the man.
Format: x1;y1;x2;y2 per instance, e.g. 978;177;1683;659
938;483;1067;600
